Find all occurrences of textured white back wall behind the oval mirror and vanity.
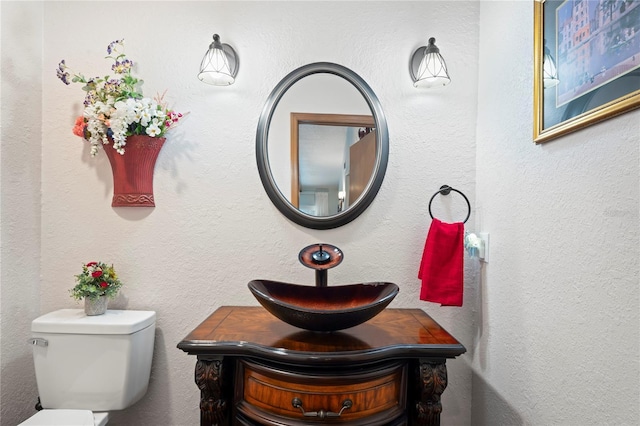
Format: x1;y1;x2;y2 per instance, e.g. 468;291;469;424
2;2;479;425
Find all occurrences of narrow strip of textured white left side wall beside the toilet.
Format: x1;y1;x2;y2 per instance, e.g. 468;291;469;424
0;2;43;425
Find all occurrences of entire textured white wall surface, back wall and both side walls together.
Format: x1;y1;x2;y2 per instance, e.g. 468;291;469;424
7;0;640;425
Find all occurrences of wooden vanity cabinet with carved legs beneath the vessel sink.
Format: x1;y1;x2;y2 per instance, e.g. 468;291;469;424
178;306;465;426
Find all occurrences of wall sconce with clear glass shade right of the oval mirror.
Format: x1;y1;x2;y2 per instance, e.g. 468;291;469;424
409;37;451;87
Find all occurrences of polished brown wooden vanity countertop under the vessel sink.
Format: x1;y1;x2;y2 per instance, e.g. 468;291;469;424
178;306;466;364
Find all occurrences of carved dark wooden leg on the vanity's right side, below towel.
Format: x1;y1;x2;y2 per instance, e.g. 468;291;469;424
416;360;447;426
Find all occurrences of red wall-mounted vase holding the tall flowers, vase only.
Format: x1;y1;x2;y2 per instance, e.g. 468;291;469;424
104;135;165;207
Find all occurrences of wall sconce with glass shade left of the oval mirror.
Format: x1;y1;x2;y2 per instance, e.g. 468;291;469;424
198;34;239;86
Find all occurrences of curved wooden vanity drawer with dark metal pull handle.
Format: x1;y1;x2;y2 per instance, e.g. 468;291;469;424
235;359;407;426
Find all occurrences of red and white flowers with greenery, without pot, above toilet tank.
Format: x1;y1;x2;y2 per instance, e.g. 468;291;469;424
70;262;122;300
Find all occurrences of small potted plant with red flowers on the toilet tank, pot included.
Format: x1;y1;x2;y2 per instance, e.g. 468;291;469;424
70;262;122;315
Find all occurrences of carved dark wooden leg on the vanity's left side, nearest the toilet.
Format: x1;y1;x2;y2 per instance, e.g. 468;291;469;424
195;358;228;426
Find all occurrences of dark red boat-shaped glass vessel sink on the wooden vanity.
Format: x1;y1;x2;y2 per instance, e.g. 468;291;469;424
248;280;400;331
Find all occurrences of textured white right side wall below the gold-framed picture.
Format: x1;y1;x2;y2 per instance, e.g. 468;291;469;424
472;1;640;426
